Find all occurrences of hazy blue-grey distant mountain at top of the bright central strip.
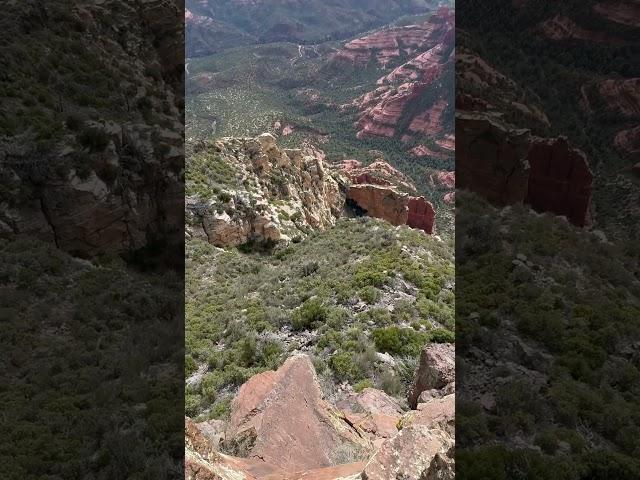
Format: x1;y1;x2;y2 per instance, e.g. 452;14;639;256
185;0;434;57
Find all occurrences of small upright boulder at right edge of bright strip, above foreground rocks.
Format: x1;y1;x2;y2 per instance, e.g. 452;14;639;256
407;343;456;408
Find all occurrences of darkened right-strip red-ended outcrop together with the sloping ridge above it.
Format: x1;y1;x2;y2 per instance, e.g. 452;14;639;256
456;45;593;227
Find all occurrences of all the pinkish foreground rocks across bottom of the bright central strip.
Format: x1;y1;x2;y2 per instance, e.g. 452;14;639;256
185;346;455;480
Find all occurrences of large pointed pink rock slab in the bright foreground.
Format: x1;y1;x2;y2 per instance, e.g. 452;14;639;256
225;355;371;472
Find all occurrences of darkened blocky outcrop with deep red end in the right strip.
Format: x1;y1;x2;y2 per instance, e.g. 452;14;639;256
456;113;593;226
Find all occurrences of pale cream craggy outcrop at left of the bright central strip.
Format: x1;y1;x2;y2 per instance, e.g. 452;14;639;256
186;134;344;247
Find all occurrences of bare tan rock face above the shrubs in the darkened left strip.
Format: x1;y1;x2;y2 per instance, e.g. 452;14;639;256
0;123;184;257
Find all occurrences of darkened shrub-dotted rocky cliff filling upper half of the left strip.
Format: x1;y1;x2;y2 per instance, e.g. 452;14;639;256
0;0;184;256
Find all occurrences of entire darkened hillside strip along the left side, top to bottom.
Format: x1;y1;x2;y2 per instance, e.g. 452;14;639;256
0;0;184;480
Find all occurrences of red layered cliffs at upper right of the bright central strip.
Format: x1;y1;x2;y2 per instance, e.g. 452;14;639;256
336;9;454;144
